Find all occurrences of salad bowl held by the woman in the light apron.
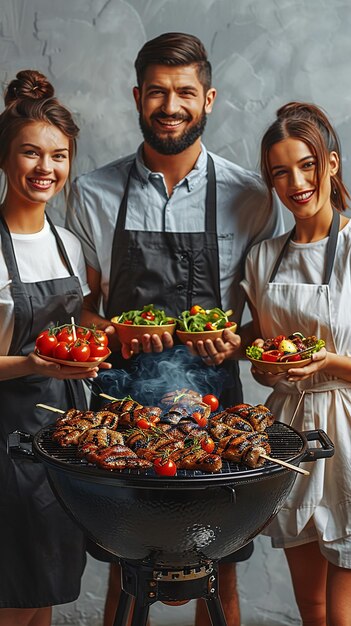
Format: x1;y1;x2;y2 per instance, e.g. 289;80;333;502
246;332;325;374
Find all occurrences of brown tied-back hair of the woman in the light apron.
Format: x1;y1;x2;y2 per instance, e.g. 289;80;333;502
261;102;350;211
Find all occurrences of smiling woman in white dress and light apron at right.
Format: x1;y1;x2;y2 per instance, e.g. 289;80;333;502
242;102;351;626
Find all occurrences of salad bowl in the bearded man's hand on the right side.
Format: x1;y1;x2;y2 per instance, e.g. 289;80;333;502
176;304;237;344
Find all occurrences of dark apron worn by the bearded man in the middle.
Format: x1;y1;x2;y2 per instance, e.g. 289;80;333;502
105;155;242;406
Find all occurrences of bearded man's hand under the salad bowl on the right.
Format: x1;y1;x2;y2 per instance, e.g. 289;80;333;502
186;329;241;365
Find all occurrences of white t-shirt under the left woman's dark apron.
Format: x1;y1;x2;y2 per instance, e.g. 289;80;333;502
0;220;90;356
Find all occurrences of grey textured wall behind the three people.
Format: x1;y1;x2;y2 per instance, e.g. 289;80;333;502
0;0;351;626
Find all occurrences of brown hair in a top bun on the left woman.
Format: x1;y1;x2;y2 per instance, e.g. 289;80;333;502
0;70;79;174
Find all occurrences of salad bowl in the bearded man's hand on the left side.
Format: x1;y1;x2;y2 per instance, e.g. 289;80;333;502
111;304;176;343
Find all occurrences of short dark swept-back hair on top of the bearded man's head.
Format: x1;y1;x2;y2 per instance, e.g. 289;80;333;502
134;33;212;92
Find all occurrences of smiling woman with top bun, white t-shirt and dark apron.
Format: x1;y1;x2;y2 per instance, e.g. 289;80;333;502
0;70;106;626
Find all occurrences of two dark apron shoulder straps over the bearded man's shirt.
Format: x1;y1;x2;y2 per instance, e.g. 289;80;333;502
116;154;217;233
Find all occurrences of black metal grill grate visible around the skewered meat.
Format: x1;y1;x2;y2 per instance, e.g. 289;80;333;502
35;422;305;478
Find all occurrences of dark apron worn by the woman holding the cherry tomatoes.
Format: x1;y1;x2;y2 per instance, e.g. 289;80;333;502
0;216;86;608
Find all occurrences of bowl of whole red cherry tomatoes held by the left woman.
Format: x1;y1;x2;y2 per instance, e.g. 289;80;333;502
34;324;111;368
